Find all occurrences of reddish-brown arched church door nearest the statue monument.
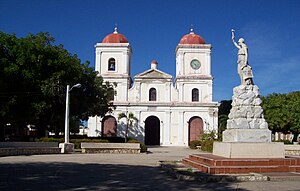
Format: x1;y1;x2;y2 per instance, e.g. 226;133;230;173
189;117;203;144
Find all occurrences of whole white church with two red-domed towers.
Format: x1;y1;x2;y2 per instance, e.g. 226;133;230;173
87;28;218;146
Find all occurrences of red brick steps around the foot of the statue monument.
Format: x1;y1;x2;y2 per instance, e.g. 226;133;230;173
182;154;300;174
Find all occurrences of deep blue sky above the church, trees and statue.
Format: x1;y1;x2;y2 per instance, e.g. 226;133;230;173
0;0;300;101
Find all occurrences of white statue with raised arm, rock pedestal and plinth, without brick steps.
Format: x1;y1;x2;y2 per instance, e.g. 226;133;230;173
213;29;284;158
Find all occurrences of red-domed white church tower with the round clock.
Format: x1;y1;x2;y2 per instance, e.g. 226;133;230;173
175;29;213;103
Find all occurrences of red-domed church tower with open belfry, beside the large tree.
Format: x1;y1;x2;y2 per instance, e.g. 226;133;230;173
95;27;132;102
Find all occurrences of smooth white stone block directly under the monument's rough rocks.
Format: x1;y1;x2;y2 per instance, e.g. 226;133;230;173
223;129;272;143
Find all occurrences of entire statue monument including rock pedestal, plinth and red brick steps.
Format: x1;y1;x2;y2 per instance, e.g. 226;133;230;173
182;30;300;174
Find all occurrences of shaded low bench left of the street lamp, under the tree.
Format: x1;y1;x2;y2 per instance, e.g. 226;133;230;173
0;142;60;156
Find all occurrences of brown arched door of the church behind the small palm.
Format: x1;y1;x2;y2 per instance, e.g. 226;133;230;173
102;116;117;137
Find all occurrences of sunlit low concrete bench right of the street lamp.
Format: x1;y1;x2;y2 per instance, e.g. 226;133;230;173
81;142;141;154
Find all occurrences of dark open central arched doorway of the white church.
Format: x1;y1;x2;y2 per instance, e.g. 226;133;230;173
145;116;160;145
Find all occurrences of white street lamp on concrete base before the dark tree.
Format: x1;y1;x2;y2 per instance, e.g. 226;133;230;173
60;84;81;153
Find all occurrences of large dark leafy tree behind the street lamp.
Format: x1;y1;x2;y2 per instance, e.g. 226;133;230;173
0;32;115;139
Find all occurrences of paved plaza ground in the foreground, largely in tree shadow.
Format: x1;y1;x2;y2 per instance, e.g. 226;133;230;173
0;147;300;191
